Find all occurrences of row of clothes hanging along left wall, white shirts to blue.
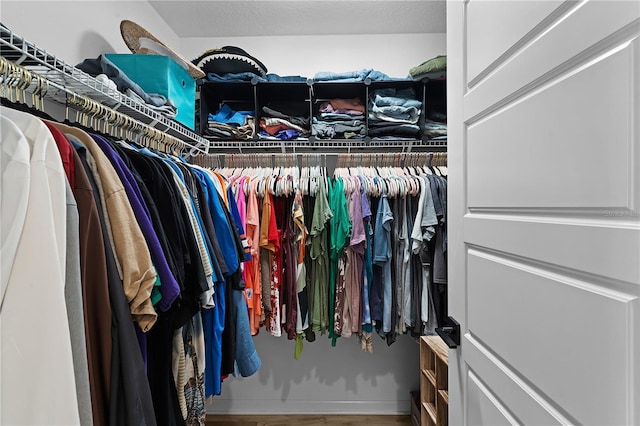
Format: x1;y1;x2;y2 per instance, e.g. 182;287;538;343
0;103;261;425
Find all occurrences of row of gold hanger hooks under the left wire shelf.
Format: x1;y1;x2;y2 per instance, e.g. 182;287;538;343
0;56;187;152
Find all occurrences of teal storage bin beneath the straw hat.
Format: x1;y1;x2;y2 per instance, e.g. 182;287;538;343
105;53;196;130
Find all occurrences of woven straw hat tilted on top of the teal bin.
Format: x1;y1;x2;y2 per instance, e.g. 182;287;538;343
120;19;205;79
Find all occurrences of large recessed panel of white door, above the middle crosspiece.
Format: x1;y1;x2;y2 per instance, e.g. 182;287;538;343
467;42;640;210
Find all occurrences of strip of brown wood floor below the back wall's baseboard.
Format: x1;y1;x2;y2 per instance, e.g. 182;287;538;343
206;414;411;426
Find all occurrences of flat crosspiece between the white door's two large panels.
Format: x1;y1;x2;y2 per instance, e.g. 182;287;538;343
464;216;640;286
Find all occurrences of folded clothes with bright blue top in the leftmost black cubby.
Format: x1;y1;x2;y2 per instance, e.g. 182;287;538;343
204;104;255;140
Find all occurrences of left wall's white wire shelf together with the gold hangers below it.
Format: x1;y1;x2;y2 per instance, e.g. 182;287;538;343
0;24;209;155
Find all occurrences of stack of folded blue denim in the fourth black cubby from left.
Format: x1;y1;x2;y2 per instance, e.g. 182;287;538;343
369;87;422;140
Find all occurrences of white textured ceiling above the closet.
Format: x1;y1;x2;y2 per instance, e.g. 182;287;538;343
149;0;446;38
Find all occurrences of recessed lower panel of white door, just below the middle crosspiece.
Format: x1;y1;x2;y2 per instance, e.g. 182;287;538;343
467;249;638;425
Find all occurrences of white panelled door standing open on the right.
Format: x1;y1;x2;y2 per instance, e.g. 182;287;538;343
447;0;640;425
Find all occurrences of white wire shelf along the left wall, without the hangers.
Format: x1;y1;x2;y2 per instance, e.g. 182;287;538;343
0;24;209;155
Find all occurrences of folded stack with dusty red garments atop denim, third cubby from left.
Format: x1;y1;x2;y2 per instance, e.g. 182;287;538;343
311;98;366;139
